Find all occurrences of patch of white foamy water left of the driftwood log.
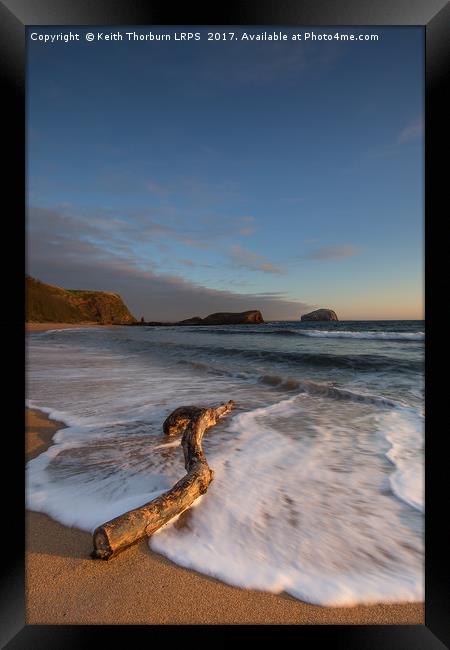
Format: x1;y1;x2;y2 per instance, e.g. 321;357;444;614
26;420;181;532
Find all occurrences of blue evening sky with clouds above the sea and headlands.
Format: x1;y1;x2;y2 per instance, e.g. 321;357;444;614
27;26;424;321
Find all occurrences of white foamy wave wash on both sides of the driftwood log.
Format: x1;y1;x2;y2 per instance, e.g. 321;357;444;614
27;395;423;606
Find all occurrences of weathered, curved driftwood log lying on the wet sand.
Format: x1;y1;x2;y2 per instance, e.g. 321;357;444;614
91;400;234;560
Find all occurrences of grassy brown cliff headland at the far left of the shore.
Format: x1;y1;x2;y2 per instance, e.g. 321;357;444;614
25;276;135;325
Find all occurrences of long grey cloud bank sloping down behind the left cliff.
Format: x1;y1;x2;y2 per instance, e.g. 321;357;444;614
27;208;310;321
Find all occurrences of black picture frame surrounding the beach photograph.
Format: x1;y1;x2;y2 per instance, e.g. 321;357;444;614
0;0;450;650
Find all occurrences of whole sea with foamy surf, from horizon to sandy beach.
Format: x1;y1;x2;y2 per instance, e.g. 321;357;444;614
26;321;425;606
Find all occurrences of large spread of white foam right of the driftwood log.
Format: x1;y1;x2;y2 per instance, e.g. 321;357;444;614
150;396;423;606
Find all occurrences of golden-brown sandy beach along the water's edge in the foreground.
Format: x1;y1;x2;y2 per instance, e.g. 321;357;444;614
25;408;425;625
